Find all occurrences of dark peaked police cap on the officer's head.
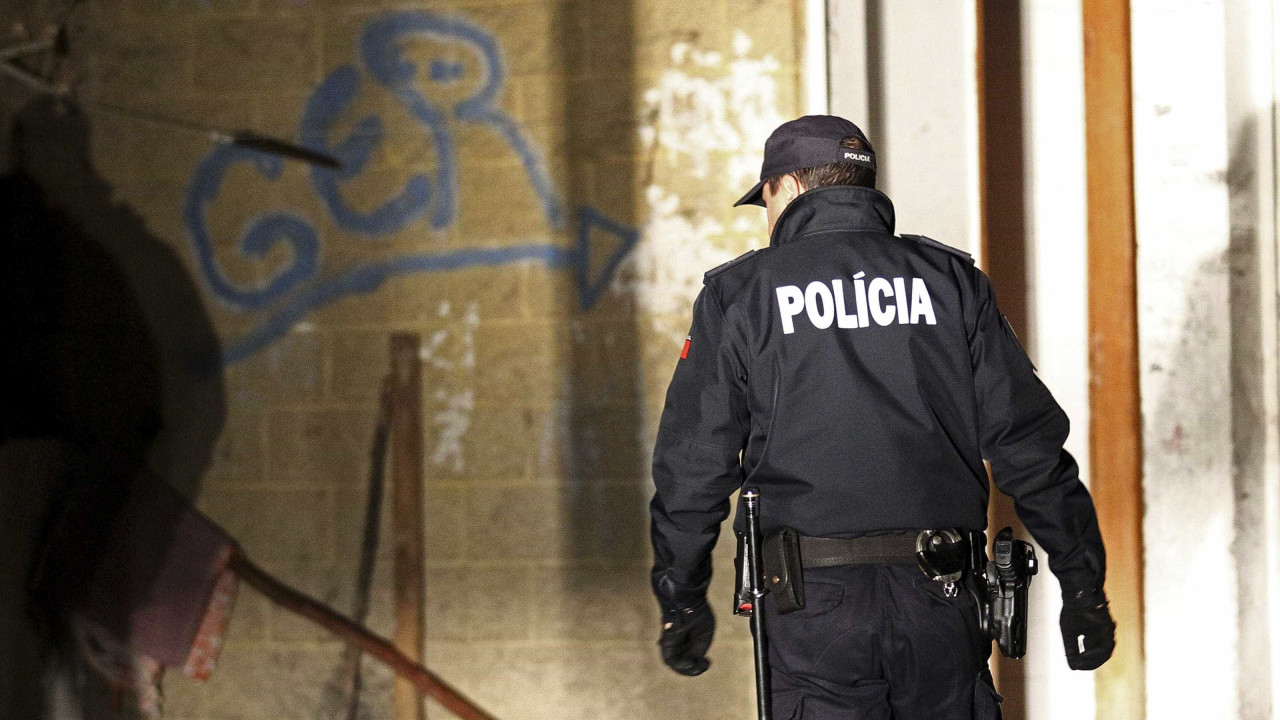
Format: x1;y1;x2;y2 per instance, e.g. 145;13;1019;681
733;115;876;208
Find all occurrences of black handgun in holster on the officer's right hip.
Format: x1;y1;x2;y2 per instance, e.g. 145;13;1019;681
982;520;1039;660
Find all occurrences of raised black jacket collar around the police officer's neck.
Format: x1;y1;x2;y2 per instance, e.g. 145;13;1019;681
769;184;893;246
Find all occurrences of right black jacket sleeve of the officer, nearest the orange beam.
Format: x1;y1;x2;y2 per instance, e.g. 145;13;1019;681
969;269;1106;596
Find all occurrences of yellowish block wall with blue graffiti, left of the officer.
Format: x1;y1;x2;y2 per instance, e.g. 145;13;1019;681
4;0;799;720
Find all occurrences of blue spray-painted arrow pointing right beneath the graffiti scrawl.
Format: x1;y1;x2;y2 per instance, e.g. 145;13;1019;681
223;208;640;365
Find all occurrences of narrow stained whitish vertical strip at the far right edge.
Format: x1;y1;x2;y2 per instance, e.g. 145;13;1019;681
1226;0;1280;720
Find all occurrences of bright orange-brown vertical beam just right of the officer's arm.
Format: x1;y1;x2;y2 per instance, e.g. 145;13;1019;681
1083;0;1146;720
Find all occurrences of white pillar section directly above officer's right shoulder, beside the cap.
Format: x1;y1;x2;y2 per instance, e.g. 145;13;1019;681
828;0;980;252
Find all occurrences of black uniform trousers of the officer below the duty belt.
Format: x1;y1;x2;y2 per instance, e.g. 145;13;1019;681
764;565;1001;720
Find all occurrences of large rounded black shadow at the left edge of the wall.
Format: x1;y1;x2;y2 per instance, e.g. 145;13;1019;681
0;100;225;720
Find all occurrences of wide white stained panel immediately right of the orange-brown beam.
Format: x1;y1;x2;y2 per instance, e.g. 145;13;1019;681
1132;0;1238;719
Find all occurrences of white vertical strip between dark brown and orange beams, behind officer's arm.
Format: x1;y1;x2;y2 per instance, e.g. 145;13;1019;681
1021;0;1096;720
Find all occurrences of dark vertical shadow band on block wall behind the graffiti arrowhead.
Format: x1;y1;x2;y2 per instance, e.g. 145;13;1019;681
556;0;649;576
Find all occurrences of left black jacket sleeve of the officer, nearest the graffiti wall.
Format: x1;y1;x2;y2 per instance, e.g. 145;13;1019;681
649;286;750;612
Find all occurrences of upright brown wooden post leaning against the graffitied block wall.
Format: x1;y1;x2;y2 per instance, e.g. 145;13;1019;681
390;333;425;720
